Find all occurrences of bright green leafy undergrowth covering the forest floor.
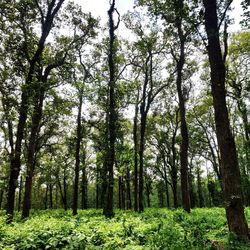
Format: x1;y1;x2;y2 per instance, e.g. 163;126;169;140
0;208;250;250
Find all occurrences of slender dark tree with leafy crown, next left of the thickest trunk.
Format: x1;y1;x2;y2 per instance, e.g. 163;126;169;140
138;0;200;212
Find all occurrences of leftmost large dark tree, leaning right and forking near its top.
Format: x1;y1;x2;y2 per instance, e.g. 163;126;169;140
3;0;64;222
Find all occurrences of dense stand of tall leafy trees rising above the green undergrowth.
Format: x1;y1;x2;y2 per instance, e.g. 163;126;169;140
0;0;250;242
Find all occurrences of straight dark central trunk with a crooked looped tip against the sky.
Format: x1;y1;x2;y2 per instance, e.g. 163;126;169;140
103;0;119;218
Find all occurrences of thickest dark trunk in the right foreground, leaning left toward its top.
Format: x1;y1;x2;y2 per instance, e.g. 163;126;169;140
203;0;249;239
